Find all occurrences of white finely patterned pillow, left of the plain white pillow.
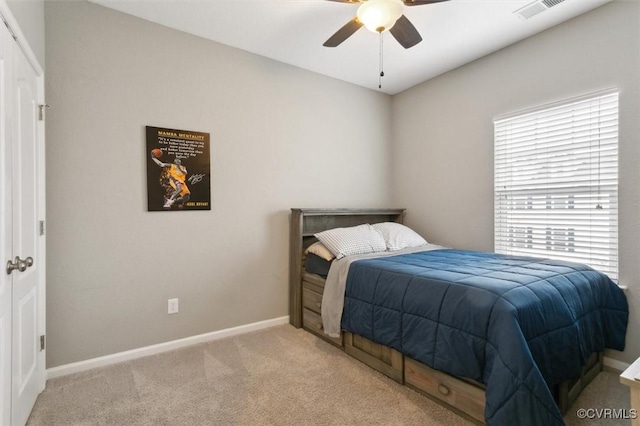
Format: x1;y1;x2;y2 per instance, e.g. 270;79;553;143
315;223;387;259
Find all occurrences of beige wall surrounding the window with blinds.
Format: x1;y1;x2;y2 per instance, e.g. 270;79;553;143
392;1;640;362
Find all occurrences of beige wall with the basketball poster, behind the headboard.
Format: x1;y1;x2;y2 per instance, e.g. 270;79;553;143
45;2;391;368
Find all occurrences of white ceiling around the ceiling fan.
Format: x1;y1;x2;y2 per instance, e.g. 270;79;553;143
90;0;611;94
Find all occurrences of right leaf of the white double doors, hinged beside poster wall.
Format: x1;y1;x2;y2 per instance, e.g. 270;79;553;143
11;24;44;425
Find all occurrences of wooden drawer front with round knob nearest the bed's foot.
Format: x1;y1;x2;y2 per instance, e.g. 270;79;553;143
404;357;486;423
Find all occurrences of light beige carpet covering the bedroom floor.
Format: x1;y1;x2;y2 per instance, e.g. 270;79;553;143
27;325;630;426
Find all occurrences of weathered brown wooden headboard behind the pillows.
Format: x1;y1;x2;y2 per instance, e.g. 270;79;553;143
289;209;405;328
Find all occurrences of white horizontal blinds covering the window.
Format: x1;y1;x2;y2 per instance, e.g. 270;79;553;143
494;91;618;280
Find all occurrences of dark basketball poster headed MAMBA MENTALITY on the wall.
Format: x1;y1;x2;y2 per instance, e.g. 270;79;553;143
146;126;211;211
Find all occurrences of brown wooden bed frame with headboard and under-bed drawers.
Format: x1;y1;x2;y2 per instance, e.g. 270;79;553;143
289;208;603;424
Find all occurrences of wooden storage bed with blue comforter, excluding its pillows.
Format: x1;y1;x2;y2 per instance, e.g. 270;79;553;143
290;209;628;425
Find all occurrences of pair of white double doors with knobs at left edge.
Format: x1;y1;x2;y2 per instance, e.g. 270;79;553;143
0;14;45;425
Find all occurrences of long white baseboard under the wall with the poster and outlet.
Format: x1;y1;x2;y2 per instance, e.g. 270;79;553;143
46;316;289;380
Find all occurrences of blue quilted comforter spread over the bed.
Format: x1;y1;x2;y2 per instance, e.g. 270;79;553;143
342;249;628;425
